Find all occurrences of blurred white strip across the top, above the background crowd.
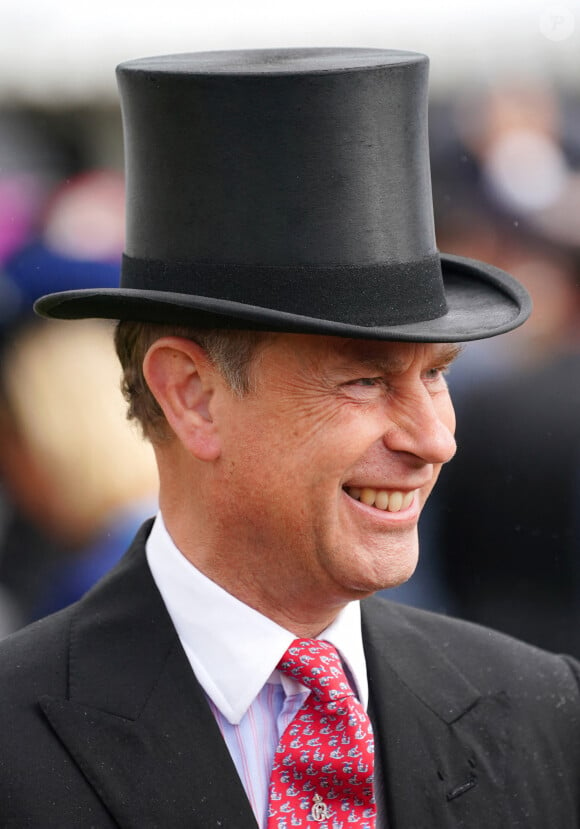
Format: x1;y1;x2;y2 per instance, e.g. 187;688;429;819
0;0;580;104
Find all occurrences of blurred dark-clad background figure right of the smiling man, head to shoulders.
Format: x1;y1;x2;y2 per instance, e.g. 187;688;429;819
400;88;580;655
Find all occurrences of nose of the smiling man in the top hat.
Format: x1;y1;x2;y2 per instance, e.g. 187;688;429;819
383;384;457;464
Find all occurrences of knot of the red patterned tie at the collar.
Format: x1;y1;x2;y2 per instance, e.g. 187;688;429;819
278;639;354;702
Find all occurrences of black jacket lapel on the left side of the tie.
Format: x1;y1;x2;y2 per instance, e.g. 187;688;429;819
40;528;256;829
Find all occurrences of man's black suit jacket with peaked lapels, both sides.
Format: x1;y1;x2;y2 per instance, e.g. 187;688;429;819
0;527;580;829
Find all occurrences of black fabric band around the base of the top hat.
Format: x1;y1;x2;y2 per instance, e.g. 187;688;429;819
121;253;447;326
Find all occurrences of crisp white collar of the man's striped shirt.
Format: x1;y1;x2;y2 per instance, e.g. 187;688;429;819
146;513;368;724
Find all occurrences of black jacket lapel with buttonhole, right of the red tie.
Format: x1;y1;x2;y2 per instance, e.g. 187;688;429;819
363;599;508;829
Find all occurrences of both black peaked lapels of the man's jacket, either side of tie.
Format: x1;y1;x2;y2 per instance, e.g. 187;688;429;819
40;526;508;829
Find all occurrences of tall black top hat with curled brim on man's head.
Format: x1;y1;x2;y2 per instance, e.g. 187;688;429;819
31;49;531;342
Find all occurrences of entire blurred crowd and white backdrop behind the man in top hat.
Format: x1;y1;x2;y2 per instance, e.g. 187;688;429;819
0;0;580;656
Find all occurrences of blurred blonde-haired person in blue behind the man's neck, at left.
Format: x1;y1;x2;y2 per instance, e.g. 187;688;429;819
0;321;157;617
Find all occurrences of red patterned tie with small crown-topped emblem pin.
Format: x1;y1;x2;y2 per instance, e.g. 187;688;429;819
268;639;376;829
